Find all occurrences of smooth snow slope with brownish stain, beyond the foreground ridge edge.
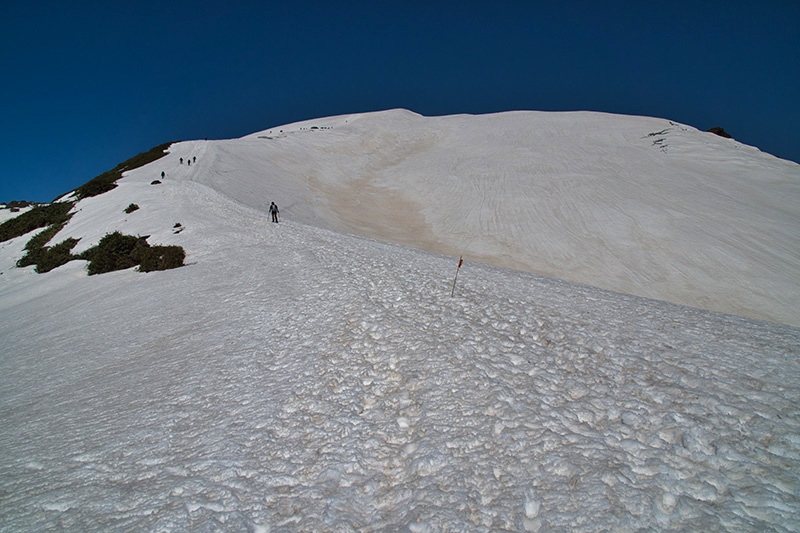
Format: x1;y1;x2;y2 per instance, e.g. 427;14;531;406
181;110;800;325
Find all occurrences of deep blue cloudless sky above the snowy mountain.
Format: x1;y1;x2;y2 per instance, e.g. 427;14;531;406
0;0;800;202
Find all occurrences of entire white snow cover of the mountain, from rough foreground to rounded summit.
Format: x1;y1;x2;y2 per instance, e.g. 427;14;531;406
0;111;800;532
